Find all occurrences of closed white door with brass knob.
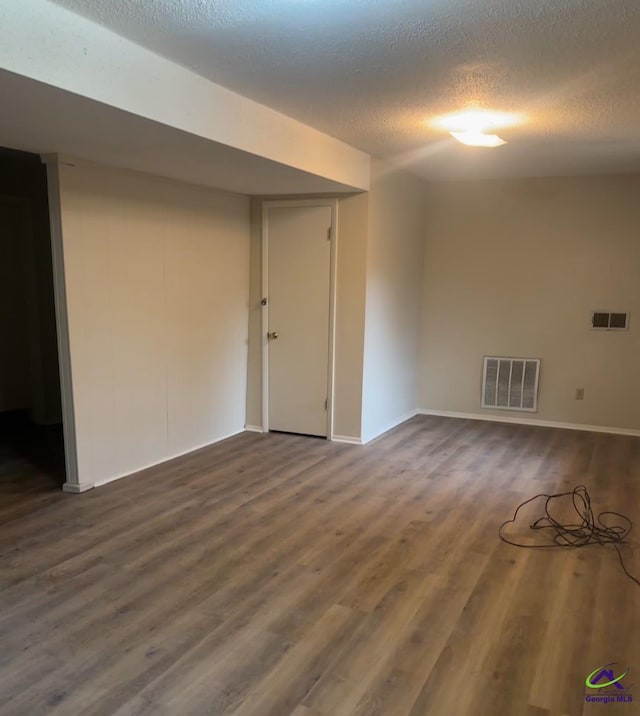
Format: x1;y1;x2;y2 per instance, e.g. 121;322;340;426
267;206;333;436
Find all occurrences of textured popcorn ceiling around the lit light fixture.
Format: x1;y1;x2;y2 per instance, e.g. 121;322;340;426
50;0;640;179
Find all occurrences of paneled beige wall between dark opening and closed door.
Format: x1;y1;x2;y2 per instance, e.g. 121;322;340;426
59;165;249;484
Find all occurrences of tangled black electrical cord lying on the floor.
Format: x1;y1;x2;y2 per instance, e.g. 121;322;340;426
498;485;640;586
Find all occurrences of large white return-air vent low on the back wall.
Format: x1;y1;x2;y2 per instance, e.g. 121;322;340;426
482;356;540;413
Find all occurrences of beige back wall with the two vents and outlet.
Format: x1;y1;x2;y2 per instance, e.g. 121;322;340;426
420;176;640;429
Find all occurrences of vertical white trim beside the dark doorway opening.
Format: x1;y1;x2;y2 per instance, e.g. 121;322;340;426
41;155;88;493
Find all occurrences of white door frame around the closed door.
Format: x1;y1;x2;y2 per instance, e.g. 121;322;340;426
260;199;338;440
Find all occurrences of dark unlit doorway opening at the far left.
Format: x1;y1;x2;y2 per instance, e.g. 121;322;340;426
0;148;65;510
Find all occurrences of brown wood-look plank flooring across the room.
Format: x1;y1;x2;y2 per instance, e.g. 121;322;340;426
0;417;640;716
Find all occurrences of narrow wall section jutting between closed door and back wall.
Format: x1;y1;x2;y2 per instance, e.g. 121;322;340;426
362;161;426;441
